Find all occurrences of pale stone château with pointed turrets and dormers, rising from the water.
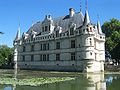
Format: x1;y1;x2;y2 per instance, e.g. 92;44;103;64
14;1;105;72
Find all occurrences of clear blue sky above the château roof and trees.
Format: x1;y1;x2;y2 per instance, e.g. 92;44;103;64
0;0;120;47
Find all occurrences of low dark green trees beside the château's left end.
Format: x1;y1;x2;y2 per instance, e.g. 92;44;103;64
0;45;13;65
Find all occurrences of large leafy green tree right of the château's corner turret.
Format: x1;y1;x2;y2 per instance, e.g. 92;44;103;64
102;18;120;59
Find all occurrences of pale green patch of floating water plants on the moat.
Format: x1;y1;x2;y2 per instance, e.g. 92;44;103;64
0;77;75;86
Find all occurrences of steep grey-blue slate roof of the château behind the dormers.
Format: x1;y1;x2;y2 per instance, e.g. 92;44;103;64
27;12;84;34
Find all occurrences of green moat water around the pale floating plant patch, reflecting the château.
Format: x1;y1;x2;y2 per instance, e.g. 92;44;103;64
0;70;120;90
